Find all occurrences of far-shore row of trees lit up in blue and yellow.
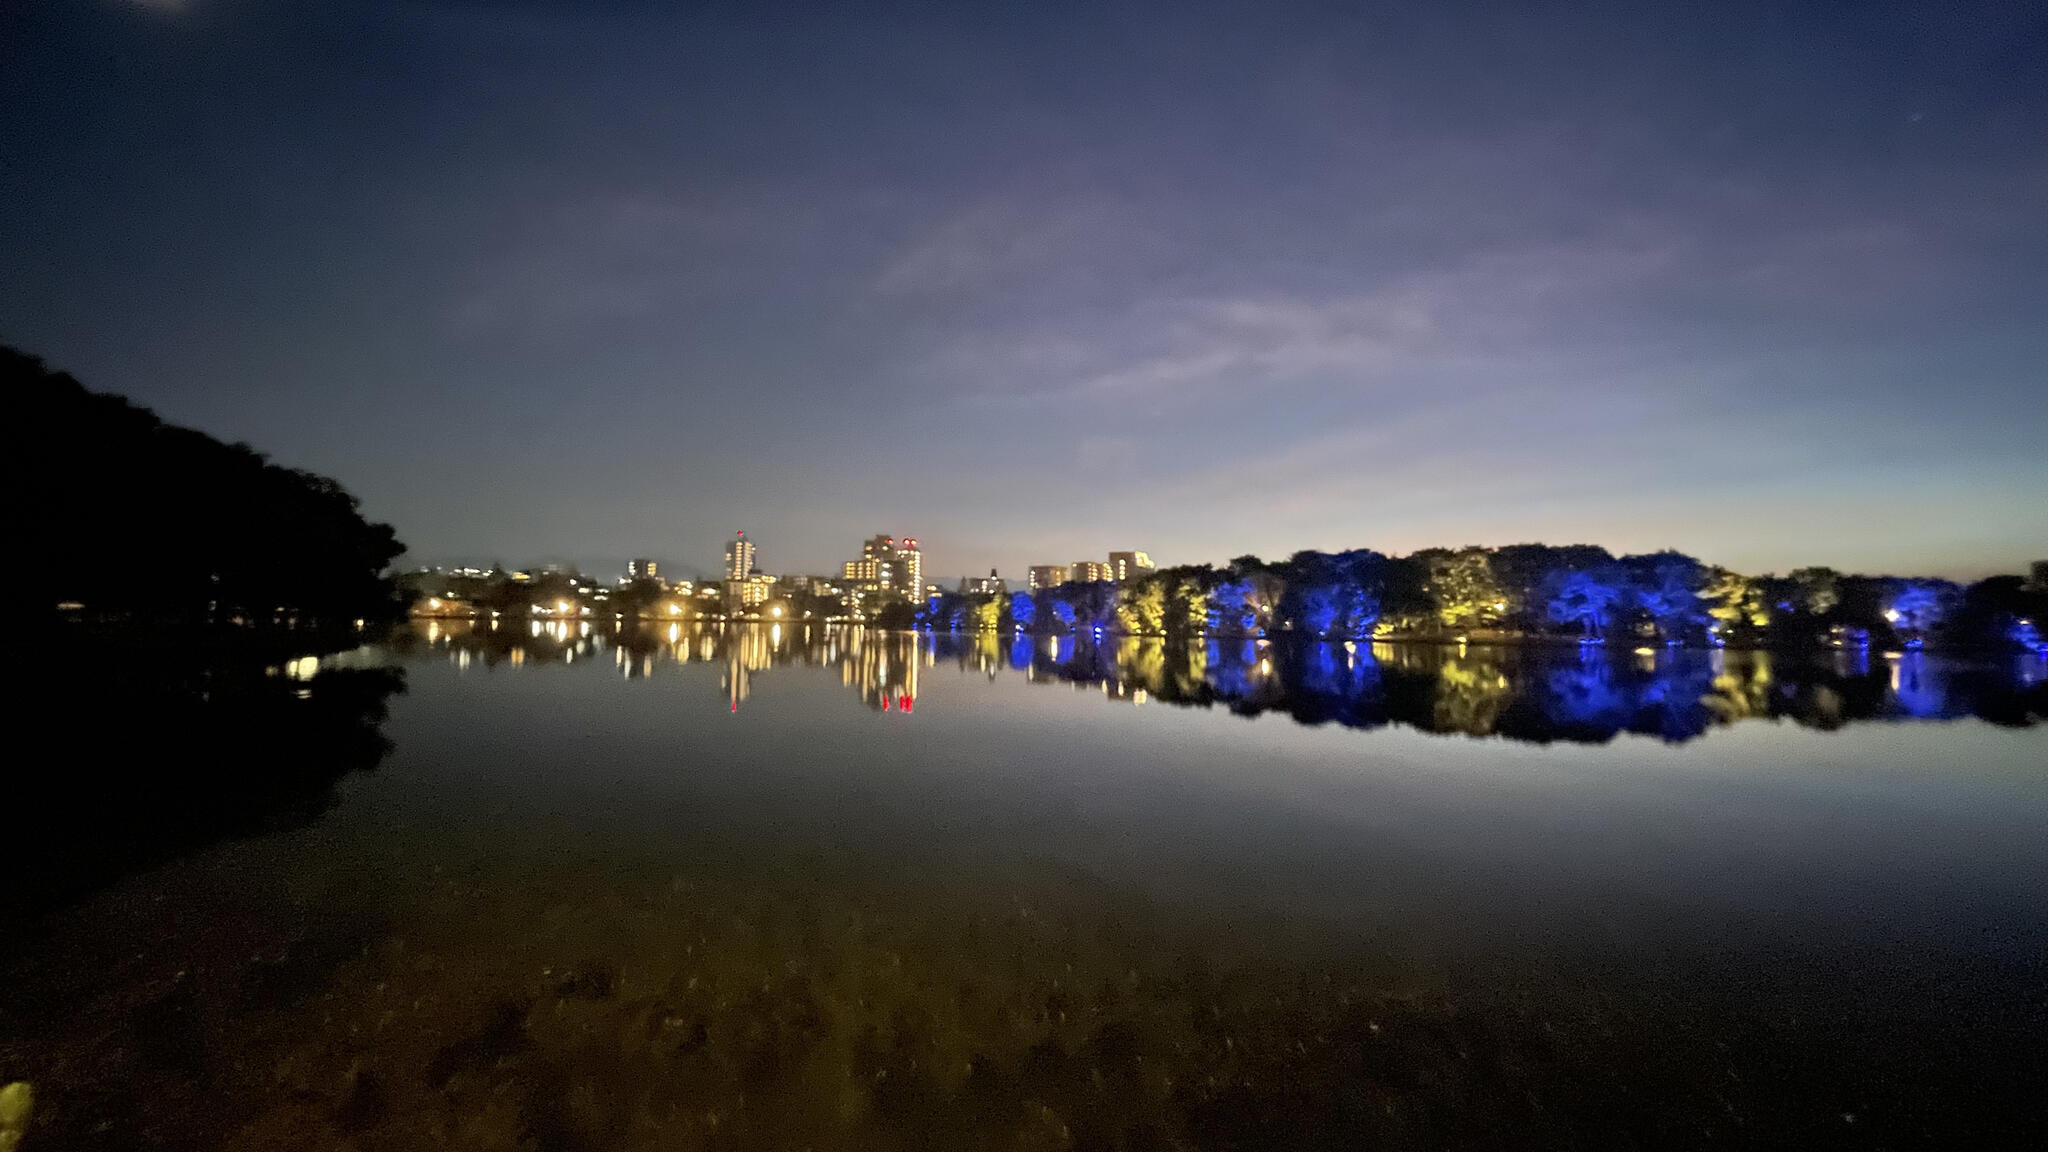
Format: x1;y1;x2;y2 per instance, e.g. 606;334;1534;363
918;543;2048;648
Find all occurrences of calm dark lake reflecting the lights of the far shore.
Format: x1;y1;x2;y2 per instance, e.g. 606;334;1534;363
0;621;2048;1152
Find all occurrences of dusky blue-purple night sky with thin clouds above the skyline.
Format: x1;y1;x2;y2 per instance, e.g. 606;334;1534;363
0;0;2048;578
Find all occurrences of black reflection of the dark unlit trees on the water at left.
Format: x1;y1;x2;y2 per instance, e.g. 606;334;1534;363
14;635;403;914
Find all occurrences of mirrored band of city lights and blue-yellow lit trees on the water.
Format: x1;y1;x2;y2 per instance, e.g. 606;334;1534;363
401;619;2048;742
